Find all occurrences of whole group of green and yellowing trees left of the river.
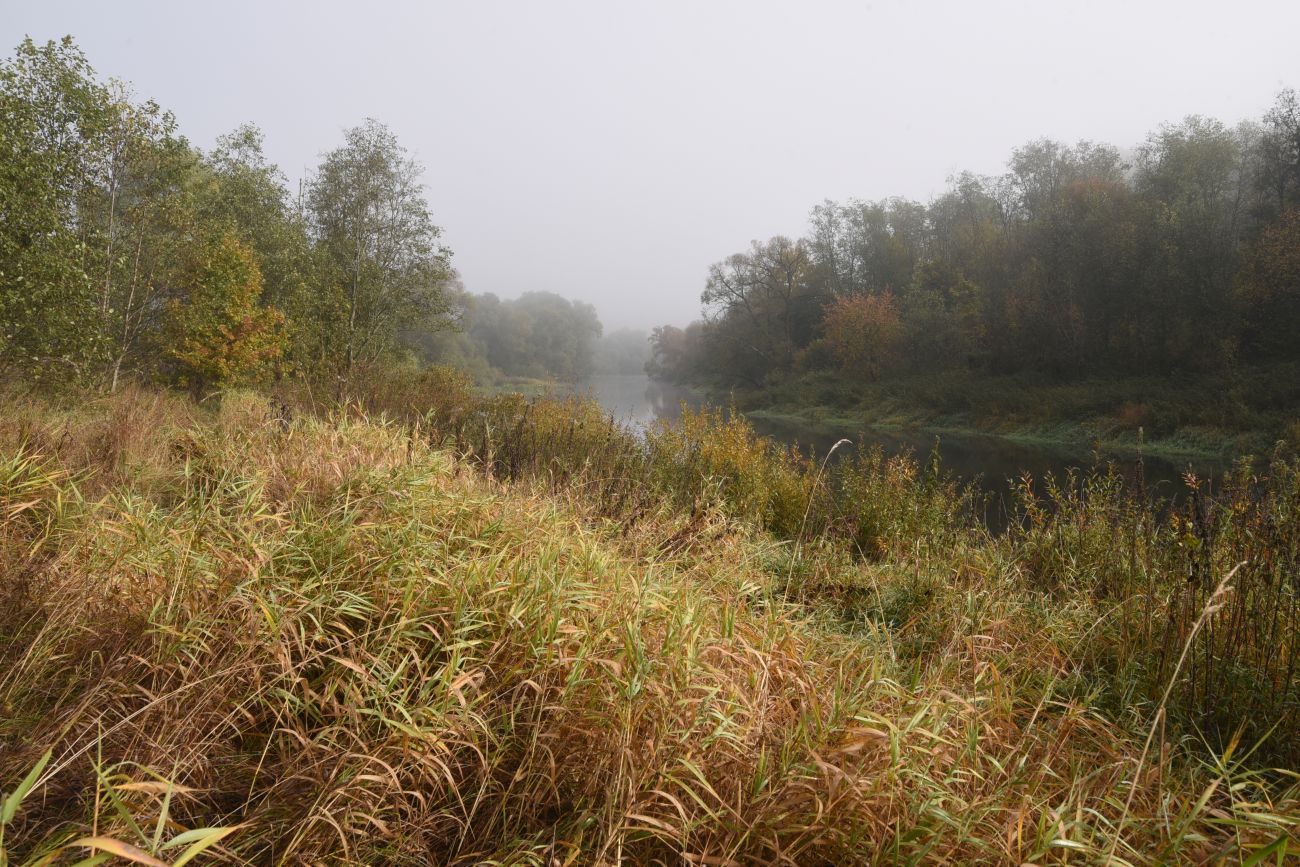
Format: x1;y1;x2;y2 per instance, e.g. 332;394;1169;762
0;39;454;394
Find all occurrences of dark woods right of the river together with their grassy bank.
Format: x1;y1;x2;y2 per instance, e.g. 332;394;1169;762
647;88;1300;488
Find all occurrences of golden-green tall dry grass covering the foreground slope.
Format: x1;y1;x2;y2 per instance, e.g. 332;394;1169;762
0;393;1300;866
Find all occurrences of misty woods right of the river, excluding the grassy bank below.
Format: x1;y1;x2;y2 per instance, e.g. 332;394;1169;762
649;90;1300;387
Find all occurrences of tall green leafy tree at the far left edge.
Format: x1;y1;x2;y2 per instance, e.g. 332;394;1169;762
0;39;195;387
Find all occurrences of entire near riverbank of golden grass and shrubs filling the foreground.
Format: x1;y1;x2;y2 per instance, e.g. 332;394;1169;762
0;382;1300;864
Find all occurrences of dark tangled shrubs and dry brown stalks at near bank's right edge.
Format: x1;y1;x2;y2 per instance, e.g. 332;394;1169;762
995;458;1300;766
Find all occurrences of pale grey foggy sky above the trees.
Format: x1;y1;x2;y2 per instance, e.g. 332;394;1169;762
0;0;1300;329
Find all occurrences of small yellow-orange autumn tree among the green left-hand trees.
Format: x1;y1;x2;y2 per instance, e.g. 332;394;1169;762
165;234;283;395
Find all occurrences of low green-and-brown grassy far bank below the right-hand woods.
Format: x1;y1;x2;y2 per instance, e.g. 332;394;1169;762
712;365;1300;464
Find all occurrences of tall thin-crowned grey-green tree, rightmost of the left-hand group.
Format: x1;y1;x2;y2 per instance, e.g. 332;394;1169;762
307;120;451;393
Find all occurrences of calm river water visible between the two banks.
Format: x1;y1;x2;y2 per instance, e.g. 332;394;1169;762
561;374;1227;524
